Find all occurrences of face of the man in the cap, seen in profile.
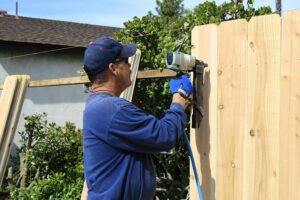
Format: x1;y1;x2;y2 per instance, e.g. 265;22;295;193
115;58;131;90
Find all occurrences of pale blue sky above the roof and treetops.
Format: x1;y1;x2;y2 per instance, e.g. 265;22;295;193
0;0;300;28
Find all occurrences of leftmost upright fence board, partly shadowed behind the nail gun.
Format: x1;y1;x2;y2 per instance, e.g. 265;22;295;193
190;24;218;200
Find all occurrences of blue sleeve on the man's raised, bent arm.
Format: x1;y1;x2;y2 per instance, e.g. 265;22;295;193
107;103;186;153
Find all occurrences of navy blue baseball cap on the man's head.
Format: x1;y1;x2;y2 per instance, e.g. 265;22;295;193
83;37;136;75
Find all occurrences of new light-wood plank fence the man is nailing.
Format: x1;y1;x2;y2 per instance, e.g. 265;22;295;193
190;10;300;200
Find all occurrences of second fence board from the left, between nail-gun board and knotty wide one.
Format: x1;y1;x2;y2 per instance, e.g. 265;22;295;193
216;20;248;200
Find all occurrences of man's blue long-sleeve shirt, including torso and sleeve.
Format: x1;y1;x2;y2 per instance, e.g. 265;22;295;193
83;93;186;200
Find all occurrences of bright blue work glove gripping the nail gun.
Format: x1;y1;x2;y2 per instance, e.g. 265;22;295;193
170;75;193;99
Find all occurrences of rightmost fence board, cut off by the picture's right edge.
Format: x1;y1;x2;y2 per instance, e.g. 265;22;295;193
279;10;300;200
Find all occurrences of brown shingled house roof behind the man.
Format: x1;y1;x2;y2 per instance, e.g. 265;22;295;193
0;15;120;47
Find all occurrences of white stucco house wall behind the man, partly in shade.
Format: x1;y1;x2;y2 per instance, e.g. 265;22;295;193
0;44;87;148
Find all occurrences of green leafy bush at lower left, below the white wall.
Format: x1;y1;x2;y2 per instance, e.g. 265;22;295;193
5;113;83;199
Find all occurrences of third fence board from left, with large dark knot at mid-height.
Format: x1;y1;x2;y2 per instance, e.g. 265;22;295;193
243;14;281;200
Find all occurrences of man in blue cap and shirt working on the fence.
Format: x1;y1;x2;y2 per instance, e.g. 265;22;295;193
83;38;192;200
